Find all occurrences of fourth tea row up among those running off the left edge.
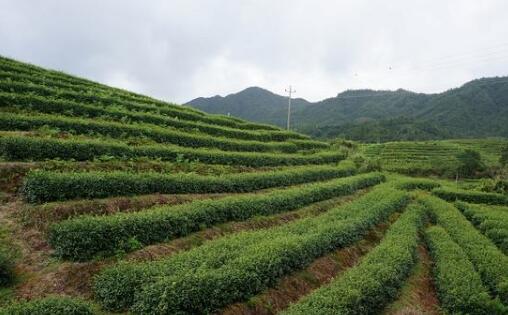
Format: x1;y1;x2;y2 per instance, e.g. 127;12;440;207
0;68;280;130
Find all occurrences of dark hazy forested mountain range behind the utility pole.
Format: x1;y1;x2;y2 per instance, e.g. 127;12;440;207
187;77;508;142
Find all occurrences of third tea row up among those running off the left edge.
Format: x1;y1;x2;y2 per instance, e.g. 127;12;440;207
0;92;310;143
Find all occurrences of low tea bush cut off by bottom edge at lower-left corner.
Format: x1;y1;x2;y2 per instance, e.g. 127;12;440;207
0;296;94;315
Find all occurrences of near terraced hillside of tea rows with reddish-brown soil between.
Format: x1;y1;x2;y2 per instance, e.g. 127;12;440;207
0;58;508;314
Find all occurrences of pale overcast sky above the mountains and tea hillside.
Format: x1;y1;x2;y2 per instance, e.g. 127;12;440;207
0;0;508;103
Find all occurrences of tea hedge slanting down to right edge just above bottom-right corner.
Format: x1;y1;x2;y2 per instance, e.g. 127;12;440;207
420;196;508;304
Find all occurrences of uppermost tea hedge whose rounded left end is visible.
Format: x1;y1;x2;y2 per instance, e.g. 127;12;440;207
22;166;353;202
